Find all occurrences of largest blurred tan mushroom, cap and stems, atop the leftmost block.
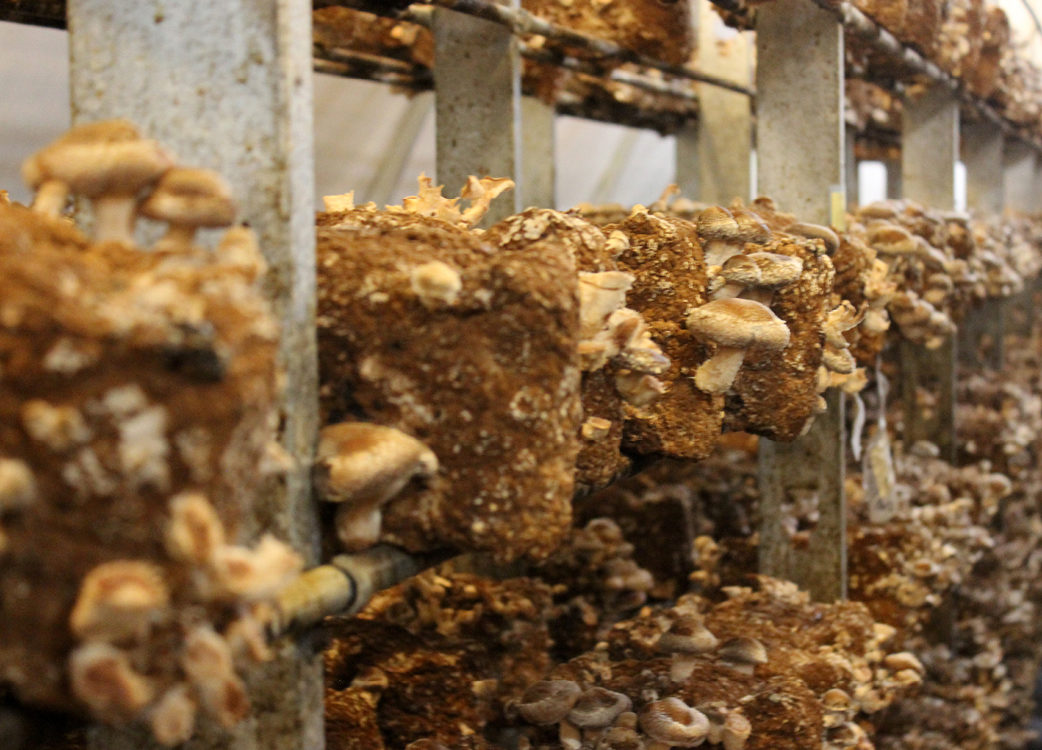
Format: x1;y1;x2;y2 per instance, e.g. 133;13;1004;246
22;120;174;244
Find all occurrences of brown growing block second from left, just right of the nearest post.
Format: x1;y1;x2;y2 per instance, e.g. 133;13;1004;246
318;208;581;559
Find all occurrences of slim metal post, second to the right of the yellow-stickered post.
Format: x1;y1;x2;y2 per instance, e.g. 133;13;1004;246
959;121;1007;368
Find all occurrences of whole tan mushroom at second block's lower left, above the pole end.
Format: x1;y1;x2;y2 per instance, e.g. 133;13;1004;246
313;422;438;552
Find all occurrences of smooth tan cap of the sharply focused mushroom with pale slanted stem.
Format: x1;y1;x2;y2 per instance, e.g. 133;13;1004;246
688;298;789;351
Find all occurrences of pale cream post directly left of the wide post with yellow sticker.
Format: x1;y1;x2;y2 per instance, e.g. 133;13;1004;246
676;2;752;205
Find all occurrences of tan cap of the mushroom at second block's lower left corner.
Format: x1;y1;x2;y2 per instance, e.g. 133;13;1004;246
314;422;438;503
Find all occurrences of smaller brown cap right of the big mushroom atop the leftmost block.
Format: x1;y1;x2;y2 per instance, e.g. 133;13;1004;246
140;167;235;227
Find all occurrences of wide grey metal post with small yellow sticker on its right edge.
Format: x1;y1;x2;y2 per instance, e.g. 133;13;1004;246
756;0;846;601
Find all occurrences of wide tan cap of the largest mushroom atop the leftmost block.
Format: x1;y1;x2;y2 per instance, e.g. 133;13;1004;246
22;120;174;198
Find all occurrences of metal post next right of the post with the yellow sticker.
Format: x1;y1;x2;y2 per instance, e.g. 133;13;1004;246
900;84;959;463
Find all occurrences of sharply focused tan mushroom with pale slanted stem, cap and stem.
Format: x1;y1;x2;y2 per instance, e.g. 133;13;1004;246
688;299;789;394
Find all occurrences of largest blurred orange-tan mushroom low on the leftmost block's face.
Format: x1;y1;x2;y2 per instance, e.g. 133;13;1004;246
69;559;170;642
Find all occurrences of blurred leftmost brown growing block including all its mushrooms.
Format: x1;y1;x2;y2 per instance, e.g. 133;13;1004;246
0;120;293;745
